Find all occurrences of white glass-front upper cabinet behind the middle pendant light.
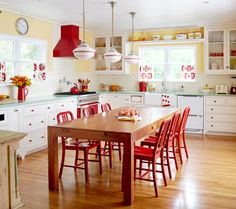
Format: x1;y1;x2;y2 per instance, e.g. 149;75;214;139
94;35;127;74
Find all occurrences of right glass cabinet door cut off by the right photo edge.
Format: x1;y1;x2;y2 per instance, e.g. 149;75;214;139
227;29;236;73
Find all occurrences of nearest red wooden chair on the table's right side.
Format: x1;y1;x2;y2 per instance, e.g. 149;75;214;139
134;119;171;197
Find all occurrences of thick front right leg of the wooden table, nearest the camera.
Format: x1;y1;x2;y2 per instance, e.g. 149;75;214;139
122;138;134;205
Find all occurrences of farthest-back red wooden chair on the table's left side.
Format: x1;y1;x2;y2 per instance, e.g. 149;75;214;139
101;103;121;168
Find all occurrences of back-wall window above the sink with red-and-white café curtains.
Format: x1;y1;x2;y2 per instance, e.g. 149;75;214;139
139;46;196;82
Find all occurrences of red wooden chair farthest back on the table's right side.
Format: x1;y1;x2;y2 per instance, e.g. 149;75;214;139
175;107;190;164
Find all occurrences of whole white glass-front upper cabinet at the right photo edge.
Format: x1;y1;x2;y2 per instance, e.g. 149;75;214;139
205;29;236;74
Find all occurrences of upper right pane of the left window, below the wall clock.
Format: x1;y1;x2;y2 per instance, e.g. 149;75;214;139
20;43;41;61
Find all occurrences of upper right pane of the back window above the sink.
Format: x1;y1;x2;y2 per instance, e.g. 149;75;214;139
169;48;195;64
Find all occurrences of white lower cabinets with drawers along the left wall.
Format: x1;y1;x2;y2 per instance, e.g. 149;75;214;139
0;98;77;158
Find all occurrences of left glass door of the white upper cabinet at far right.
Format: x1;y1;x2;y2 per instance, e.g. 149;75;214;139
206;30;226;72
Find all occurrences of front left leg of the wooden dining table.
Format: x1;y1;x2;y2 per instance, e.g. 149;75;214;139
48;127;59;191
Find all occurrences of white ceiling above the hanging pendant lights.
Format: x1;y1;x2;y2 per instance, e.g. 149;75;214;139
0;0;236;33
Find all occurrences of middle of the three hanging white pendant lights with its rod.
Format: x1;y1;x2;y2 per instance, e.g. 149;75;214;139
104;1;122;63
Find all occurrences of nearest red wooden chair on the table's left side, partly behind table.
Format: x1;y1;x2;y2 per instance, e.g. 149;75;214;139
57;111;102;183
